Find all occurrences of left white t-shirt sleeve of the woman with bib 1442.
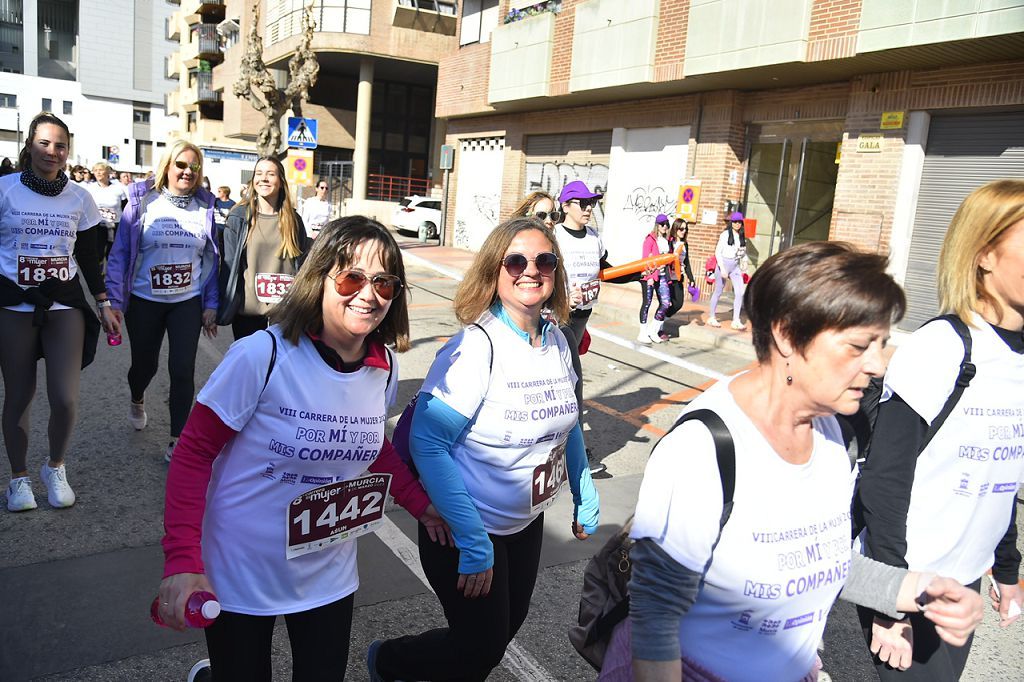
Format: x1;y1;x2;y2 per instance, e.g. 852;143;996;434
196;332;274;431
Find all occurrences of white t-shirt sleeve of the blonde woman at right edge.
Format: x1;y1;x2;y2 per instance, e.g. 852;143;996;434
882;319;964;424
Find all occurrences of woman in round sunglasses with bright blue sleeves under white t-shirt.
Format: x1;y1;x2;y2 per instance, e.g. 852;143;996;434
367;218;598;682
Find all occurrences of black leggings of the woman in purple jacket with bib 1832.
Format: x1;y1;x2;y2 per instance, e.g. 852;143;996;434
125;296;203;438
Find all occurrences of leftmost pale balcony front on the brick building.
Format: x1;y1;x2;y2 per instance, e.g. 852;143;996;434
487;12;555;103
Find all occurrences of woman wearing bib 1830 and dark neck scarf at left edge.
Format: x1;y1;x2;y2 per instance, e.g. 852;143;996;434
0;114;120;512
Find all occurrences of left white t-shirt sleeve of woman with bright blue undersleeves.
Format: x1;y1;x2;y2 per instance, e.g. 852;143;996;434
420;328;492;419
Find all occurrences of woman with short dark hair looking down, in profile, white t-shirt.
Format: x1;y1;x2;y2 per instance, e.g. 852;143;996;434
614;242;981;682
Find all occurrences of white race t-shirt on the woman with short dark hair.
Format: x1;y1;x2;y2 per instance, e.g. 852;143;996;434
631;381;853;682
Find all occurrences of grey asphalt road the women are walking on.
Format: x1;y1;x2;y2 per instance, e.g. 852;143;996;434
0;256;1024;682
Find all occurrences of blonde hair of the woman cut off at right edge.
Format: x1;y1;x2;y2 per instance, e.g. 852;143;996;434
938;179;1024;324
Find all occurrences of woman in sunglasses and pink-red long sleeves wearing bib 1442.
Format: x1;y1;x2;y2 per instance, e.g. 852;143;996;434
158;216;450;680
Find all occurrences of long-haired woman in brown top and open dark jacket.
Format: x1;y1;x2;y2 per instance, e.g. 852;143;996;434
217;157;312;340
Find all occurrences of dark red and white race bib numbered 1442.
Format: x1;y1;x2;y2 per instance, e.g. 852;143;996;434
285;474;391;559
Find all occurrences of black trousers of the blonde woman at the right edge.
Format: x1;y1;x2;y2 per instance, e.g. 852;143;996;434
857;580;981;682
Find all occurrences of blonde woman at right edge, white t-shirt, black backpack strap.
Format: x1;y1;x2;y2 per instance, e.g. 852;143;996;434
858;179;1024;682
